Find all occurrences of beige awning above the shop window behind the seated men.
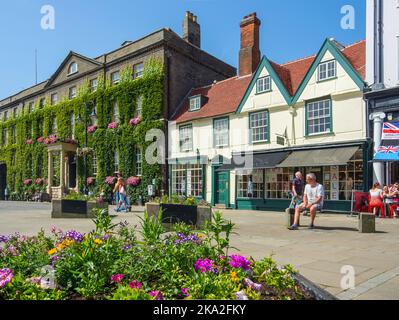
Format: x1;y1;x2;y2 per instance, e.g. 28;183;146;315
277;147;359;168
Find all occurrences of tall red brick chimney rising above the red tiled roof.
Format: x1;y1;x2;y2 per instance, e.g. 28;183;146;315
239;12;260;77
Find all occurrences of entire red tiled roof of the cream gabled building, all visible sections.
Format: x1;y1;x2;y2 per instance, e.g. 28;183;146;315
173;40;366;123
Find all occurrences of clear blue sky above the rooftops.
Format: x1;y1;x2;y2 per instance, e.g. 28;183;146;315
0;0;366;99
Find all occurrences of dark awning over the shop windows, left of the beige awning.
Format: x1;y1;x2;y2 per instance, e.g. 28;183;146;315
216;151;290;171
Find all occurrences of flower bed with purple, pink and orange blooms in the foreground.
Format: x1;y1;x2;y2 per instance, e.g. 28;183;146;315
0;211;311;300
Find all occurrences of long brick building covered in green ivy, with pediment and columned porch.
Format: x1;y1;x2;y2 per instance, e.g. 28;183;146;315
0;12;236;201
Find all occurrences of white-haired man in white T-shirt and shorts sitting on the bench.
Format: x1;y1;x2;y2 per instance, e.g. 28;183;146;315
289;173;324;230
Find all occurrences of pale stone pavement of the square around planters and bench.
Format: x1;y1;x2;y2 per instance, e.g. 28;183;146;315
0;201;399;300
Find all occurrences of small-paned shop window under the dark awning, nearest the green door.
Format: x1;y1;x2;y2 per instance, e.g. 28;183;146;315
237;170;265;199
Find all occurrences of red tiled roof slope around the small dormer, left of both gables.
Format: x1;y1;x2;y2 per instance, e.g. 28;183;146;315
173;75;252;123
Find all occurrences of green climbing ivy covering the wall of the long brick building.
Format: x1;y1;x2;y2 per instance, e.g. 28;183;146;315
0;59;165;202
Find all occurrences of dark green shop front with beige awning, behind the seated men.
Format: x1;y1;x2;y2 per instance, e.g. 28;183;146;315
219;141;369;212
